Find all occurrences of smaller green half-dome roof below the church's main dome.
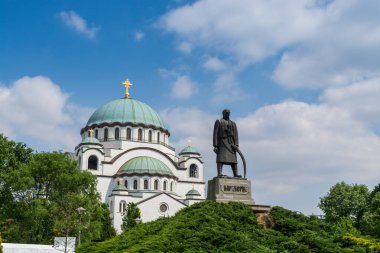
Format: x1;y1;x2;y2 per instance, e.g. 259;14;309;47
118;156;174;177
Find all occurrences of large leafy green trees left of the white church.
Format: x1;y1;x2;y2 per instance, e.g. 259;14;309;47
0;135;115;244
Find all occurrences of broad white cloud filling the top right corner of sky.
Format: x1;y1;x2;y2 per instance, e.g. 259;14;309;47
161;0;380;88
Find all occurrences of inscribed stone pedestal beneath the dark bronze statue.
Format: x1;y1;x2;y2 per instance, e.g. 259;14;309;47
207;177;255;206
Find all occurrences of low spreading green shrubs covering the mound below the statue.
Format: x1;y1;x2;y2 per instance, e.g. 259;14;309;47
77;201;364;253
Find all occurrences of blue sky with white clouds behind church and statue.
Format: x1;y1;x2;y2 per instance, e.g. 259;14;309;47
0;0;380;214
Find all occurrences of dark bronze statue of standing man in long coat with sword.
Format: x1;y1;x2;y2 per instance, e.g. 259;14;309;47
213;109;245;178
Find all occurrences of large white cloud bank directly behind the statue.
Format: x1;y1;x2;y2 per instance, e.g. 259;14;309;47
161;101;380;213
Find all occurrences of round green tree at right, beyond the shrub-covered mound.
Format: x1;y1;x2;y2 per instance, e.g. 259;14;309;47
318;182;369;224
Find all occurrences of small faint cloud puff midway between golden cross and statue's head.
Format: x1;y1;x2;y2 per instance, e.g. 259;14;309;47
171;75;198;99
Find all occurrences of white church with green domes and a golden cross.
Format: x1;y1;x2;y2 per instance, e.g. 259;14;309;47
75;80;205;232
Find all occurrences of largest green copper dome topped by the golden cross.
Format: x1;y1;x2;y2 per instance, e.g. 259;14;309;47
86;98;164;128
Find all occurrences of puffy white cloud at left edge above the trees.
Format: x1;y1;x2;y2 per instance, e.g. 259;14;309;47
0;76;93;150
